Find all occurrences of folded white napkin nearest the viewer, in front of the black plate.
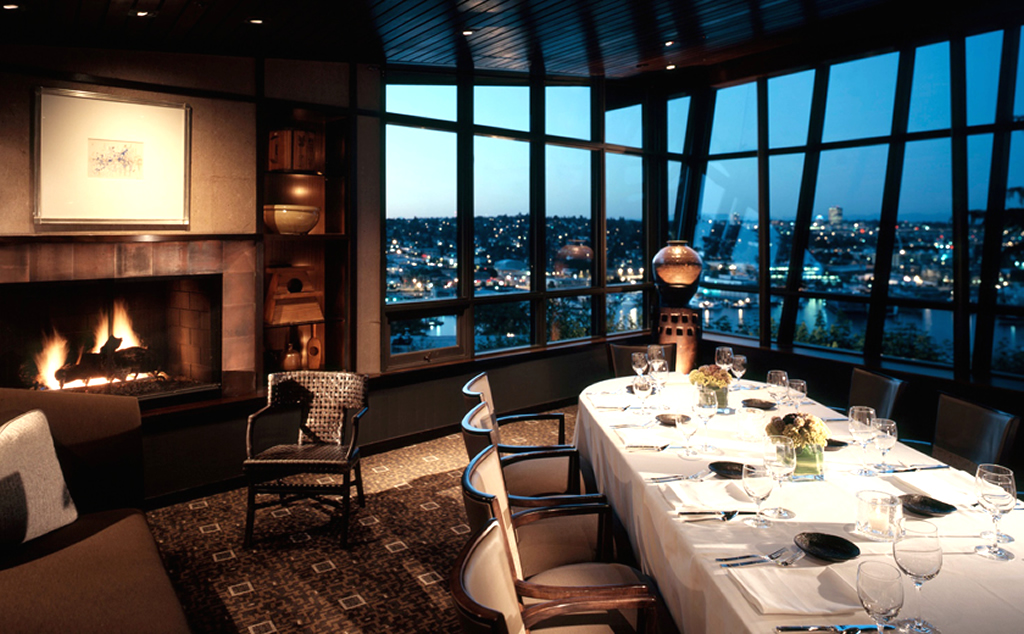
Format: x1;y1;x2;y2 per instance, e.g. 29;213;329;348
728;565;861;615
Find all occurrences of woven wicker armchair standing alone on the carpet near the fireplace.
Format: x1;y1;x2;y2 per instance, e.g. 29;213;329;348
242;370;367;547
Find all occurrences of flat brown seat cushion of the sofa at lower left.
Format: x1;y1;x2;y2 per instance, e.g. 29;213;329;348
0;509;188;634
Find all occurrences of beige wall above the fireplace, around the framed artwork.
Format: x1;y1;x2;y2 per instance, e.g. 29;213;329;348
0;47;256;236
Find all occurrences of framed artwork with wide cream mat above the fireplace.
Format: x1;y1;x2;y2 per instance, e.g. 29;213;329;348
35;87;191;225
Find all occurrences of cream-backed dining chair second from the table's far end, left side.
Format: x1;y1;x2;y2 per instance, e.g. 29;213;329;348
462;401;586;506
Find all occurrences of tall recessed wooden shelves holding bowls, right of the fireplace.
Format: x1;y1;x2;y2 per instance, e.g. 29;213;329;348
259;101;352;372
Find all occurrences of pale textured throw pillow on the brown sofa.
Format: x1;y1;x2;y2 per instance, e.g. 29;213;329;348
0;410;78;548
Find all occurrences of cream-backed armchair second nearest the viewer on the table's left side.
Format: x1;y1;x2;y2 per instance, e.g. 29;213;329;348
462;446;664;626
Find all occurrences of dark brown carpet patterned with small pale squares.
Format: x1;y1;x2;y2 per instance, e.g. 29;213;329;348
147;407;575;634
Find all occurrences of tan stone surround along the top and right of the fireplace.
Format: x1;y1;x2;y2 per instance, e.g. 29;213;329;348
0;235;259;397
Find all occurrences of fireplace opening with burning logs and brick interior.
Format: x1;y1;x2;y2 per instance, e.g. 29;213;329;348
0;274;222;400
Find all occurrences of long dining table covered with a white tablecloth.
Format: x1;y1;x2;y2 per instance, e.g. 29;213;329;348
574;373;1024;634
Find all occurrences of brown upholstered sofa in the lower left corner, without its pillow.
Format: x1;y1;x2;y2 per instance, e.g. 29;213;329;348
0;388;188;633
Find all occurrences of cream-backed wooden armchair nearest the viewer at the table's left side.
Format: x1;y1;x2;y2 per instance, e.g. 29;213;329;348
449;519;657;634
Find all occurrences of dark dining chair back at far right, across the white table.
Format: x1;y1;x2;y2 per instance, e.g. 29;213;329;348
932;393;1020;473
